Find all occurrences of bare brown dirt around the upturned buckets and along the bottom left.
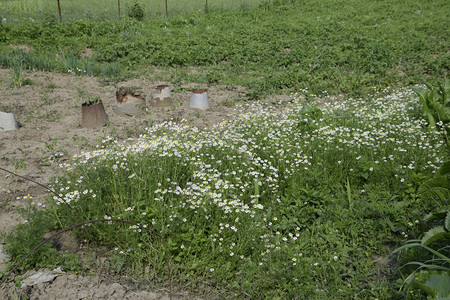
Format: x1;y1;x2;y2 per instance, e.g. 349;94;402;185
0;69;289;299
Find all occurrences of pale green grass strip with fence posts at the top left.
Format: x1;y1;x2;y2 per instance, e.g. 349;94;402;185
0;0;273;24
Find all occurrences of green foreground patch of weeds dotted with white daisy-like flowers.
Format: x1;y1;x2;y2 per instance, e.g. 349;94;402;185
5;86;446;299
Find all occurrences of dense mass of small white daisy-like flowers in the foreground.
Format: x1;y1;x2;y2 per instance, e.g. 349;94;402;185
55;86;445;272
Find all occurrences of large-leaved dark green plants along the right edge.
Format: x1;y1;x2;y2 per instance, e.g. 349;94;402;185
394;79;450;299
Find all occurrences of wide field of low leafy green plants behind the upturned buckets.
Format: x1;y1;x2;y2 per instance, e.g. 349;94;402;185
0;0;450;98
